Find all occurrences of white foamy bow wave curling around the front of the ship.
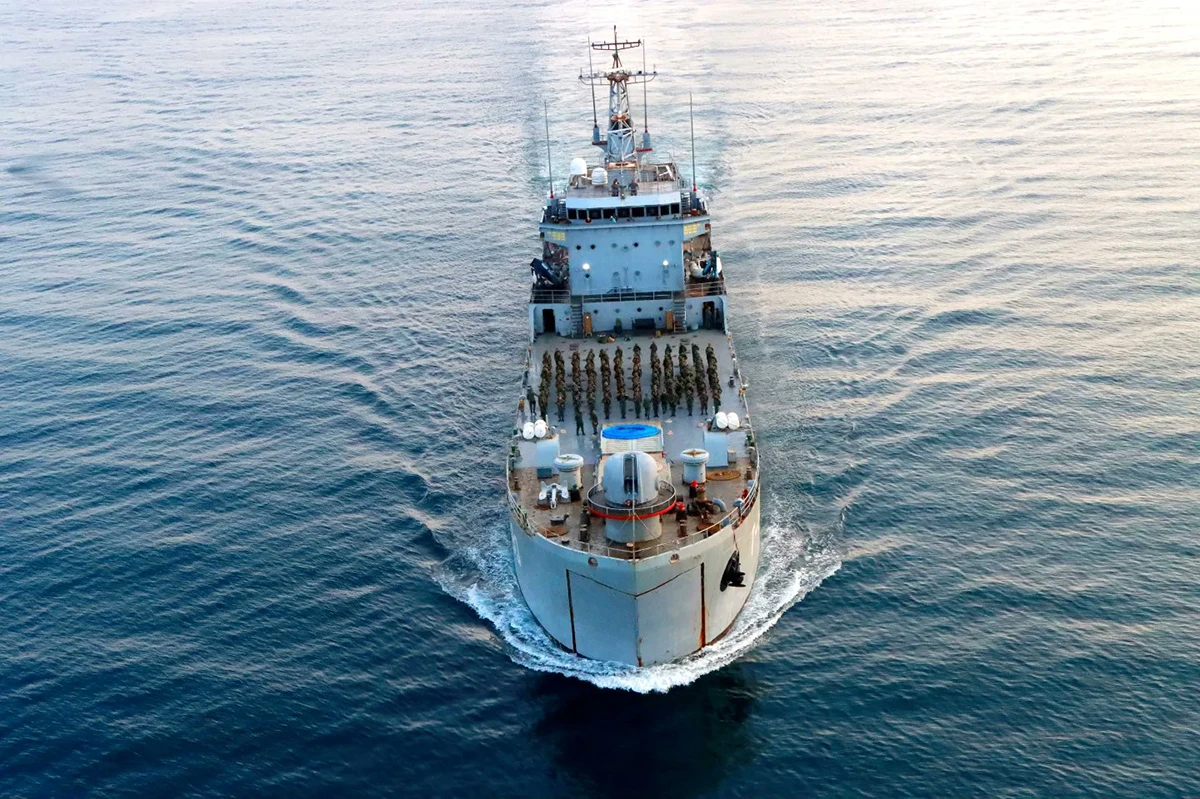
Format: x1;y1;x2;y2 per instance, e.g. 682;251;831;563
439;499;841;693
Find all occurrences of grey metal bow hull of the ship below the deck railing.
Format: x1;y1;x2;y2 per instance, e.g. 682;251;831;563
509;503;760;666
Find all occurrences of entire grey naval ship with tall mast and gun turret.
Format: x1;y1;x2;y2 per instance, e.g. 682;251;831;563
506;29;762;666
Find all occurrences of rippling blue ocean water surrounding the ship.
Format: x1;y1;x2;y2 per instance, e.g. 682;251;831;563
0;0;1200;798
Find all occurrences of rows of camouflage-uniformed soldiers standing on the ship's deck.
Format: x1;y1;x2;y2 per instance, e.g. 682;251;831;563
524;342;721;435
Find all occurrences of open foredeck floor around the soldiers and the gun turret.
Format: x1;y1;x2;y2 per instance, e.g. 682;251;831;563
509;330;757;558
